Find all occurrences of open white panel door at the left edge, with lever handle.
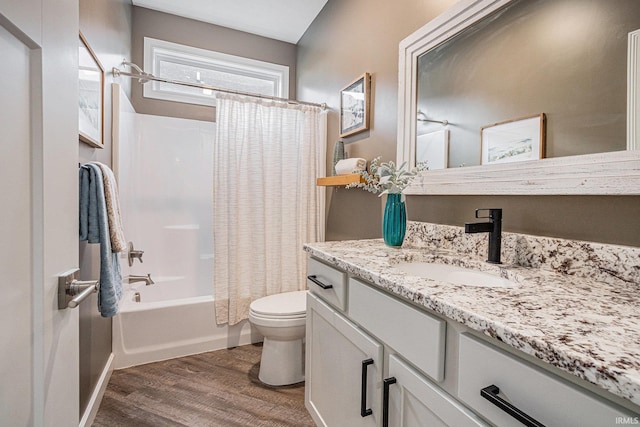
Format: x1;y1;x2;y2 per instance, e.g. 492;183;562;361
0;0;79;426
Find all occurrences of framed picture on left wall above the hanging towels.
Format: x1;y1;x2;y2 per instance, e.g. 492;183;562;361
78;33;104;148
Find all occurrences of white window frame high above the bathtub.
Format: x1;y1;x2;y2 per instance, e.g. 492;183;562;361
143;37;289;106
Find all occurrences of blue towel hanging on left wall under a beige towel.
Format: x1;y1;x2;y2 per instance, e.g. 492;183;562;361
79;164;122;317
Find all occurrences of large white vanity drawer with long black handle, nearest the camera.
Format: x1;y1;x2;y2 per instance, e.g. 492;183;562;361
458;334;636;426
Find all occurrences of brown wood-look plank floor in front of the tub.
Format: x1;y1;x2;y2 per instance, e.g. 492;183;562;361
93;344;314;427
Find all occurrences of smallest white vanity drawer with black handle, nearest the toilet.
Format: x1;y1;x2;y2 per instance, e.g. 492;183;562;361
307;258;347;311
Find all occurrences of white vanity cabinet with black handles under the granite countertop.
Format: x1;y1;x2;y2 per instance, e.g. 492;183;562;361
305;258;638;427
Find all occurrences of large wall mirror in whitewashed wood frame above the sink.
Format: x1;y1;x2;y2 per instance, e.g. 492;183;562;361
397;0;640;194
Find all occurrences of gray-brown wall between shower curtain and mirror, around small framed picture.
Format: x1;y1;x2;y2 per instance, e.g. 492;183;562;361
297;0;455;240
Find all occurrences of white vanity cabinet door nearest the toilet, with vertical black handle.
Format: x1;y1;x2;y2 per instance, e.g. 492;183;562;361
305;294;383;427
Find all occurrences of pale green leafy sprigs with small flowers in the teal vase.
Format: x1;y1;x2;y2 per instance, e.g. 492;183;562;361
346;156;428;197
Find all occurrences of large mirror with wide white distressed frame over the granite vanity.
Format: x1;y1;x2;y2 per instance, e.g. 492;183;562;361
397;0;640;195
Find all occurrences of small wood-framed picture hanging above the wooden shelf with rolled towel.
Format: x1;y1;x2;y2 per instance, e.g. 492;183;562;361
340;73;371;137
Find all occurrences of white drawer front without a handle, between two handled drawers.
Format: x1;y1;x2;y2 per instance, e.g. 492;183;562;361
349;278;447;381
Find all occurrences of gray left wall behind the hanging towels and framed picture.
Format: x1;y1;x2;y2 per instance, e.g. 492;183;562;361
78;0;131;416
